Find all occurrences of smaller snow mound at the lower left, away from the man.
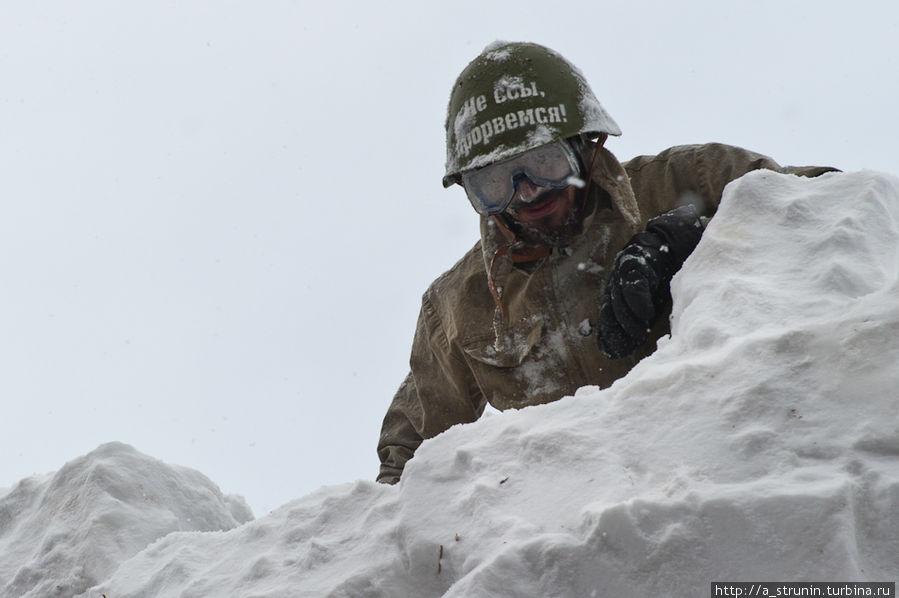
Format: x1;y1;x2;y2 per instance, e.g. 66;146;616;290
0;443;252;598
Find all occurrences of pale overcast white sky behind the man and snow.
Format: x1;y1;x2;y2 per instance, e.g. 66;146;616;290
0;0;899;516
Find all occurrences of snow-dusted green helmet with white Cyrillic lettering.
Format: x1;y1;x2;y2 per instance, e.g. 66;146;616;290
443;42;621;187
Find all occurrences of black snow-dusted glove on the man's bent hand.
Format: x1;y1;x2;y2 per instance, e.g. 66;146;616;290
598;205;702;359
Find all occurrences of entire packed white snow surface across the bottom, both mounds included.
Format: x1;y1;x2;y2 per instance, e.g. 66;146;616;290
0;171;899;598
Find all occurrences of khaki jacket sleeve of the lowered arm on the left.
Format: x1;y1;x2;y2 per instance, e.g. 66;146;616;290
377;292;486;484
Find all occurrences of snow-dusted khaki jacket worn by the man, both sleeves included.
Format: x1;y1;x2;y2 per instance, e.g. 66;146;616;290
378;144;833;483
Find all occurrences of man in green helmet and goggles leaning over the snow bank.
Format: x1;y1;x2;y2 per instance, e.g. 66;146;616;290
378;43;832;483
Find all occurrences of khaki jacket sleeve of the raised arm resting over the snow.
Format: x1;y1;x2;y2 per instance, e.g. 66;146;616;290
624;143;836;218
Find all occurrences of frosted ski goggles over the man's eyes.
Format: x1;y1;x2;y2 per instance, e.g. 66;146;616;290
462;141;583;216
